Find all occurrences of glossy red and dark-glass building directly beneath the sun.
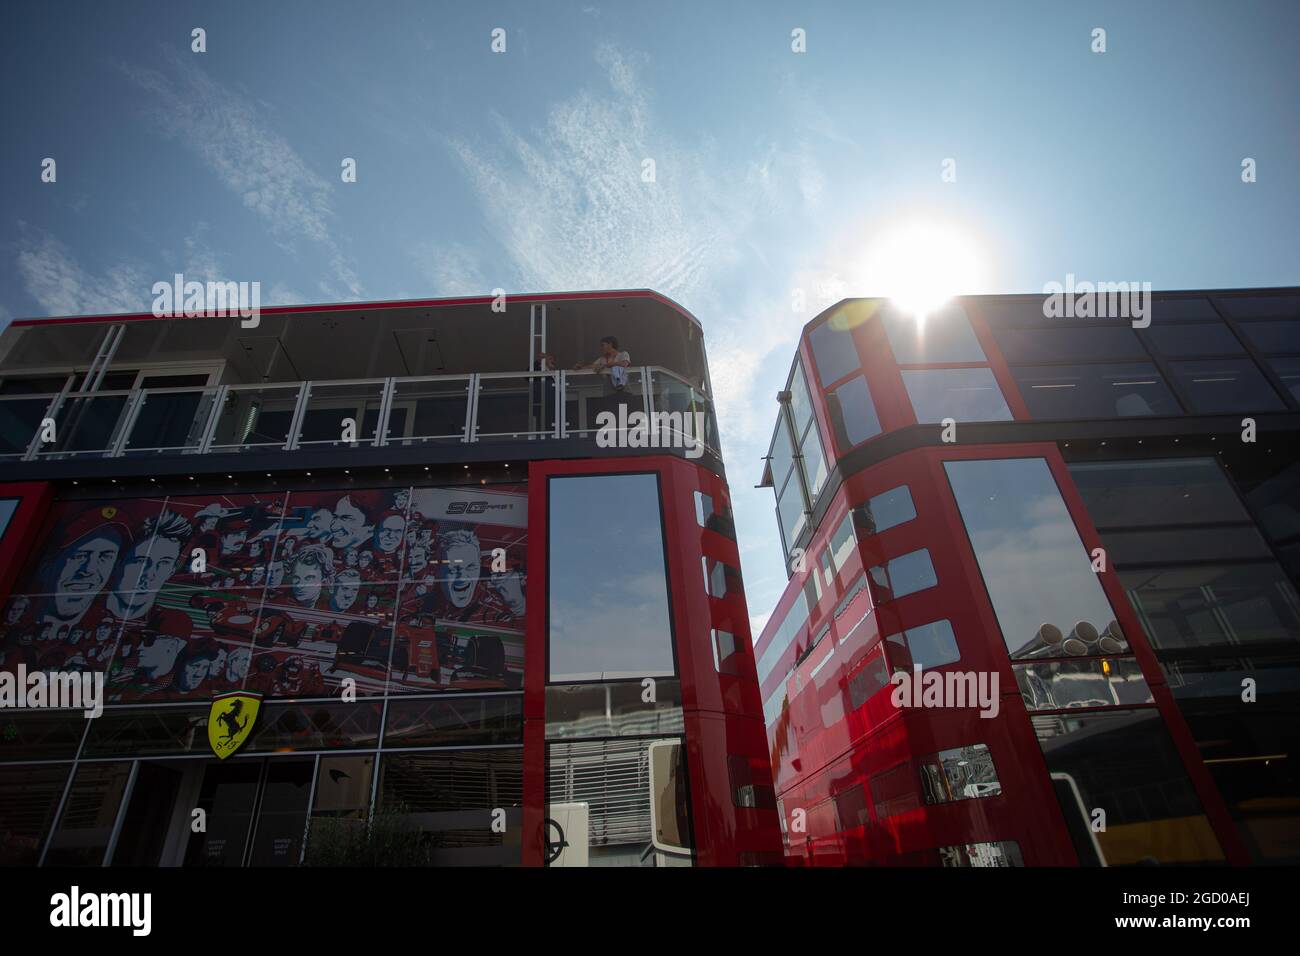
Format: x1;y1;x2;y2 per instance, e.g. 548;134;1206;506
755;290;1300;866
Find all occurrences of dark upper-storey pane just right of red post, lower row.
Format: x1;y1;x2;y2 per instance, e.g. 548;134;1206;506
1011;364;1183;419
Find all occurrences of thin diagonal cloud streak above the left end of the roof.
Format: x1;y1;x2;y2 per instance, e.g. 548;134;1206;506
121;51;363;299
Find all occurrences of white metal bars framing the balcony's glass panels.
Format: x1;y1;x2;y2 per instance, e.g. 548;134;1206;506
0;365;718;460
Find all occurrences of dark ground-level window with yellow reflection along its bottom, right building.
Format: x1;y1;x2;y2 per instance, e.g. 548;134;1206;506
1034;709;1223;866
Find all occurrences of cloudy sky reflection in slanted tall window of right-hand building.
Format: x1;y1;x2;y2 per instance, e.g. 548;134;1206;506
944;458;1114;657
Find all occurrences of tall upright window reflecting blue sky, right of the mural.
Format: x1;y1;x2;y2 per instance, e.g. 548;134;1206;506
547;475;675;680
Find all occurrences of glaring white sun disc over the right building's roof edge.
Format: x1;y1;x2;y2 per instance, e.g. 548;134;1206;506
863;221;984;321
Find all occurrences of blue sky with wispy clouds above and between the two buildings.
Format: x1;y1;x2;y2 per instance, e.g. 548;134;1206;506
0;0;1300;637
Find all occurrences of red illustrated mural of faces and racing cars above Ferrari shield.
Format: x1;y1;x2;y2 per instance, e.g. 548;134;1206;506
0;485;528;702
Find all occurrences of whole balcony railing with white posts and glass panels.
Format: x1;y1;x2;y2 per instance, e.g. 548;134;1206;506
0;365;718;462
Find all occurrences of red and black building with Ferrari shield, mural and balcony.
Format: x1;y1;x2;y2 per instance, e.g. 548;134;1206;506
0;291;780;866
